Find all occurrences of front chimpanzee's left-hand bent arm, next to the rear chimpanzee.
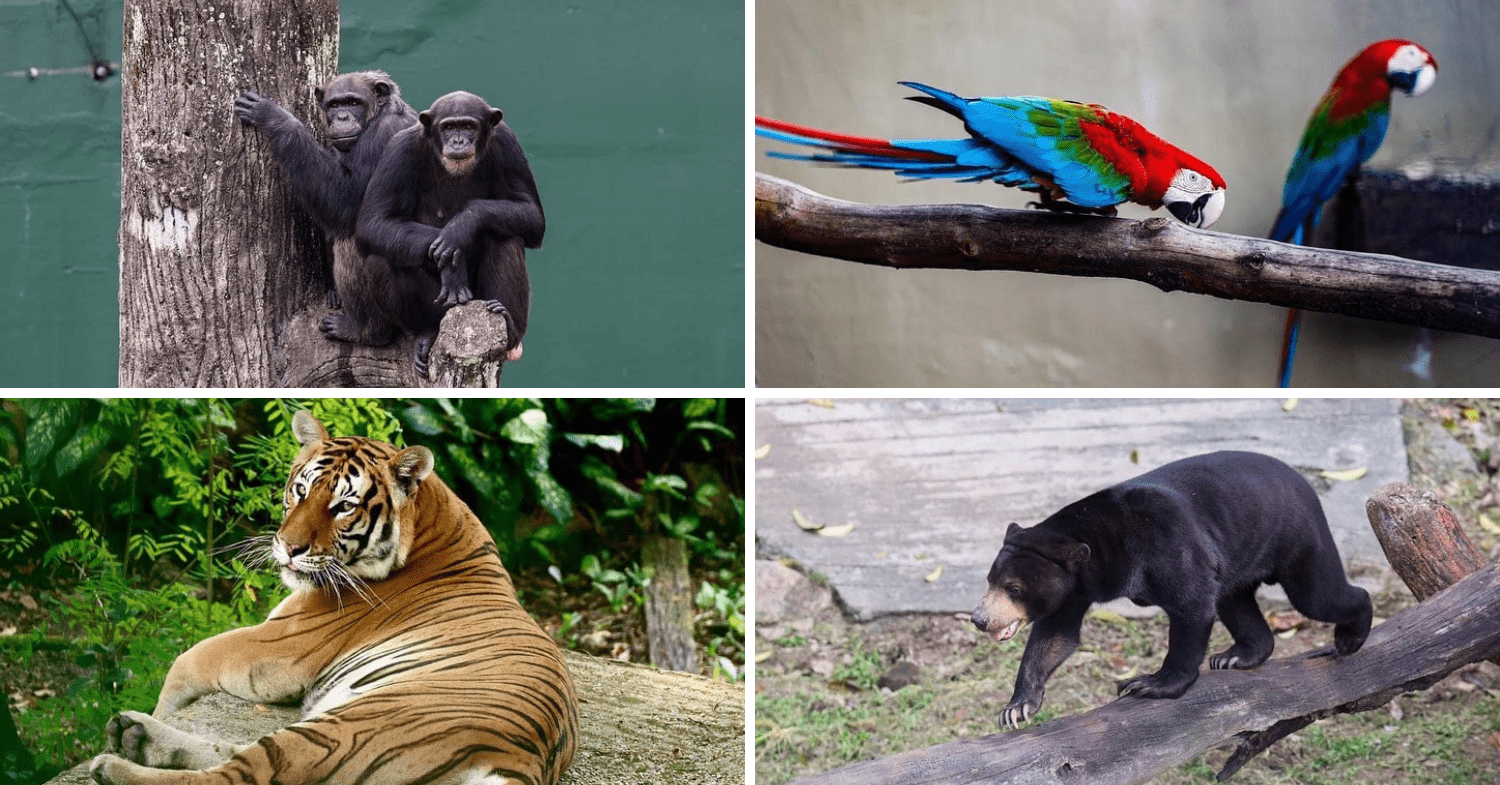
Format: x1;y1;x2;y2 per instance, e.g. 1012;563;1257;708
356;133;438;267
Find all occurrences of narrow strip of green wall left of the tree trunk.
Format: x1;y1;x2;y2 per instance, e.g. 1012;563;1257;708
0;0;120;387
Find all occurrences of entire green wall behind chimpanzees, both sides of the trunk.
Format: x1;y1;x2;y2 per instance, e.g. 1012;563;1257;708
0;0;744;387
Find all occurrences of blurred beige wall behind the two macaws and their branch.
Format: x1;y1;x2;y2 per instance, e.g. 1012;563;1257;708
755;0;1500;387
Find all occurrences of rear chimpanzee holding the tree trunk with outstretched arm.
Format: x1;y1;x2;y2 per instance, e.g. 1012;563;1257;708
234;71;417;336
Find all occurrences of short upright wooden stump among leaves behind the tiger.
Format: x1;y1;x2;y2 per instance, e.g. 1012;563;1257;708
641;534;698;671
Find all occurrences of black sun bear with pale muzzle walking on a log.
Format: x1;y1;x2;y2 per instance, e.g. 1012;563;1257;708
971;452;1371;728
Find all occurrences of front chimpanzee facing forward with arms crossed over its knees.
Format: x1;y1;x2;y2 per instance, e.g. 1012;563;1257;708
357;92;545;377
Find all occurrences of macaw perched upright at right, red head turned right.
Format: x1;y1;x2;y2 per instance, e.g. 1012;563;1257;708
1271;39;1437;387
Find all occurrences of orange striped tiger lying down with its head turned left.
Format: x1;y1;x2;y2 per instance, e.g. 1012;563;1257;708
90;411;578;785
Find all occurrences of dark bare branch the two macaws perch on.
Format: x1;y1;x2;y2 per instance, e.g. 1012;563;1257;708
755;173;1500;338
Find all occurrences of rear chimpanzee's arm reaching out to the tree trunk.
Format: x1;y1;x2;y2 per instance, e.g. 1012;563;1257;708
234;92;372;237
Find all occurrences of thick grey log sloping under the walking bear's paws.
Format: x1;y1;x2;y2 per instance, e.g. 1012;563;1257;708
798;564;1500;785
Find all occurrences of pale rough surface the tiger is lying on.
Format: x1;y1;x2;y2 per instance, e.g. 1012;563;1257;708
50;653;746;785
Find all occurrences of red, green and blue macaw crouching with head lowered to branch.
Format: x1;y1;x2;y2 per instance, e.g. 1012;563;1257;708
755;81;1226;227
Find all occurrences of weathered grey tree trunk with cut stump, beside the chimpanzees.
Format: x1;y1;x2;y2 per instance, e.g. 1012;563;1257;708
120;0;504;387
